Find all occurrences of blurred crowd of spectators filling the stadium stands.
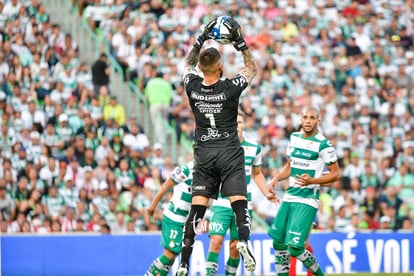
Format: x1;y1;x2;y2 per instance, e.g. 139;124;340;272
0;0;414;233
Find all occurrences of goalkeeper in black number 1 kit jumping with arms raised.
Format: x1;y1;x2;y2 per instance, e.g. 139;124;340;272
177;17;257;276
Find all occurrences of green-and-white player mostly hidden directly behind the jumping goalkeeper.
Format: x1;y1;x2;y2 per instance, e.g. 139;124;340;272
205;111;277;276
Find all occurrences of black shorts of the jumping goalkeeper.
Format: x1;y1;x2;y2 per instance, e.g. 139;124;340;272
193;146;247;199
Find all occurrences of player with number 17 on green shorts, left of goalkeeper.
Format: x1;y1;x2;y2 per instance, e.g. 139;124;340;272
145;161;193;276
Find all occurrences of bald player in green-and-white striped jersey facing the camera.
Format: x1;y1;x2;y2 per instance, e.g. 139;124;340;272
269;107;340;276
